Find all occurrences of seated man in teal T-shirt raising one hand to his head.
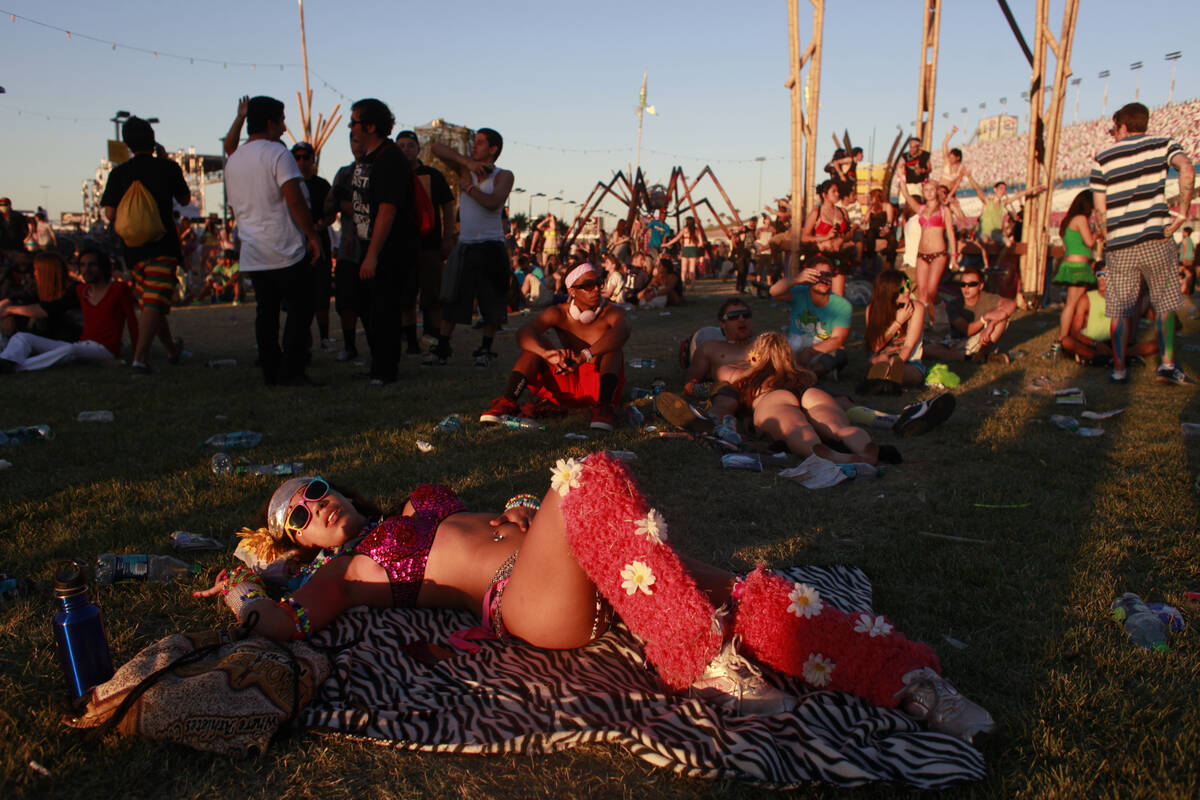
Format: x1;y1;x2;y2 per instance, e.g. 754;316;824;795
770;255;854;380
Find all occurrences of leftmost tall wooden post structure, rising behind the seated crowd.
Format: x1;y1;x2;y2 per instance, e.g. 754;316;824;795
782;0;824;275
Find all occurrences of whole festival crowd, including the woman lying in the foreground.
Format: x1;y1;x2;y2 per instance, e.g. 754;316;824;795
0;90;1195;767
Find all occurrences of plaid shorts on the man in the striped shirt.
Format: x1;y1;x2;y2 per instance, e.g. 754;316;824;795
1104;239;1187;319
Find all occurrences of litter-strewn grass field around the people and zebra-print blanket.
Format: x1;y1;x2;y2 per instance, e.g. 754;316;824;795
0;283;1200;798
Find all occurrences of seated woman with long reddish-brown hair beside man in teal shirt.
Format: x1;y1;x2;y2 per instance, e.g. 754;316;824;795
865;270;925;386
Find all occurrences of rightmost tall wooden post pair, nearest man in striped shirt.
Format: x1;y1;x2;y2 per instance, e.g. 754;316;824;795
1021;0;1079;308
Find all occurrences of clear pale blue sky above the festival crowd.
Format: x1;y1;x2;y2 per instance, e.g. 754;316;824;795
0;0;1200;219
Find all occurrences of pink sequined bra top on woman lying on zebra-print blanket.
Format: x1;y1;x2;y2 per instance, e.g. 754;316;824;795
354;483;467;608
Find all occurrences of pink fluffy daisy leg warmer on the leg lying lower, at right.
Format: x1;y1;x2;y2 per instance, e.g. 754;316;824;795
733;566;941;708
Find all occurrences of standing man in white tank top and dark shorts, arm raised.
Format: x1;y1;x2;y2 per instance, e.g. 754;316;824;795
421;128;514;367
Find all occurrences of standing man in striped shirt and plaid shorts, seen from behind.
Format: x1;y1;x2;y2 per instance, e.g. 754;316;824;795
1091;103;1195;385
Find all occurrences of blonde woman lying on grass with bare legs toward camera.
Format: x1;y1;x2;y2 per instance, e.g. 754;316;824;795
732;332;900;464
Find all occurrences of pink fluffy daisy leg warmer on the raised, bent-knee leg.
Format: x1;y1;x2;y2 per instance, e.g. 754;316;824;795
559;452;721;688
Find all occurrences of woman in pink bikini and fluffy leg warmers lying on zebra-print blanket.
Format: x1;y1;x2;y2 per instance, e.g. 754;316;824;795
196;455;992;741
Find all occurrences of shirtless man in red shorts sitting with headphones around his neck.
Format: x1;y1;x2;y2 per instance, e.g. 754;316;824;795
479;264;632;431
